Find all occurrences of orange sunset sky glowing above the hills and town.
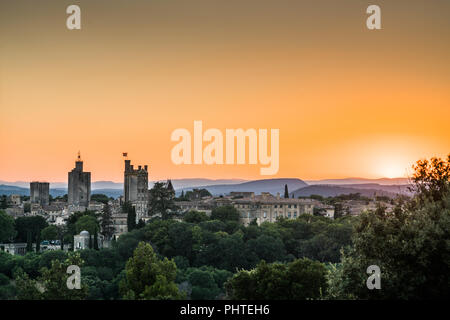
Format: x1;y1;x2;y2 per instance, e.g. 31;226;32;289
0;0;450;182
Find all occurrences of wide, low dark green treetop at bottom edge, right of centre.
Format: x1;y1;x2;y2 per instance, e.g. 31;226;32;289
225;258;327;300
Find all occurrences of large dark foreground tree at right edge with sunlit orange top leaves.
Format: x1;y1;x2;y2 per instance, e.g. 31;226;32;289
330;155;450;299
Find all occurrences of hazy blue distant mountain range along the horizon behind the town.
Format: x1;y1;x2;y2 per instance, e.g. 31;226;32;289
0;178;410;198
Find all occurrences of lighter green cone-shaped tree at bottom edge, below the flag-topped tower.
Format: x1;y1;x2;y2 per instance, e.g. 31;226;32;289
121;242;182;300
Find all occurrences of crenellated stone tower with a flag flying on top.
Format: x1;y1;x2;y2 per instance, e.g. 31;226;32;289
124;159;148;223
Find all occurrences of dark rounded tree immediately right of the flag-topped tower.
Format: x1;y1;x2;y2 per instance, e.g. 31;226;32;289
149;182;177;220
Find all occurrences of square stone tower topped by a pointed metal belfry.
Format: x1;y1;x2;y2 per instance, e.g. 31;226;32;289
68;153;91;208
